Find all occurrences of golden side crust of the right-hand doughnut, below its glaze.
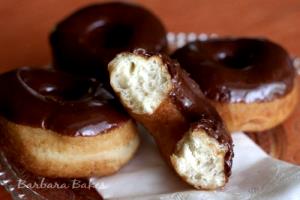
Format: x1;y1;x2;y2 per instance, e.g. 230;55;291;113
210;79;299;132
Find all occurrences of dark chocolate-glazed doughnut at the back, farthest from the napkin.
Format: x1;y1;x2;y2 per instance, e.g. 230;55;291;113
50;2;167;85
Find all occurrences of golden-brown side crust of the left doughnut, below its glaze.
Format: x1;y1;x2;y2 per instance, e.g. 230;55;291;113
0;117;139;178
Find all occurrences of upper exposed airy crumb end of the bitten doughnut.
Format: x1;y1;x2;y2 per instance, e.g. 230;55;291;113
108;53;172;114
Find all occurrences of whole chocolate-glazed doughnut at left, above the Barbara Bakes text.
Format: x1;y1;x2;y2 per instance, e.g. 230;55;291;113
0;68;139;178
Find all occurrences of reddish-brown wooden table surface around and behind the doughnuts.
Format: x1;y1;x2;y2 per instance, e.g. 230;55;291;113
0;0;300;200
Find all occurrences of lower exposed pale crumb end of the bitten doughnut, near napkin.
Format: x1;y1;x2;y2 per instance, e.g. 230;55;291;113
171;130;228;189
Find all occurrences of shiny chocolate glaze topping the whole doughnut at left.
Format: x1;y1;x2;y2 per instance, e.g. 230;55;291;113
0;67;129;136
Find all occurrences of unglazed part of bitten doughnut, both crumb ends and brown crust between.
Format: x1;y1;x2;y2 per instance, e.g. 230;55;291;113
108;53;231;189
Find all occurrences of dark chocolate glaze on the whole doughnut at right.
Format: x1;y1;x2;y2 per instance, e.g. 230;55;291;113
172;38;295;103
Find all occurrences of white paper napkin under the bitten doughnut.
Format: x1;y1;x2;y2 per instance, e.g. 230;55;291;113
90;127;300;200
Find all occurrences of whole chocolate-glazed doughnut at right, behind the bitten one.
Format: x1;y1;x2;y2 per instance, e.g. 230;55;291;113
172;38;298;131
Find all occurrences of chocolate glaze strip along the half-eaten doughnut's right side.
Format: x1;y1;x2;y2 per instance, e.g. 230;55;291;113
134;49;234;177
